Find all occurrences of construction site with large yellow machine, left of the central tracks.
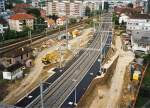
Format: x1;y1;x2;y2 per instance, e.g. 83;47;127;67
3;26;93;105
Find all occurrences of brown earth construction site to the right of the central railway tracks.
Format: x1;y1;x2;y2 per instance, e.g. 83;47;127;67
77;28;149;108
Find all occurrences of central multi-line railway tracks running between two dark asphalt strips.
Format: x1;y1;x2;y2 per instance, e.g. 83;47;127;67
24;13;111;108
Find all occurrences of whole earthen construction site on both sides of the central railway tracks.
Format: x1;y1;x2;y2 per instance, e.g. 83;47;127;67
2;13;148;108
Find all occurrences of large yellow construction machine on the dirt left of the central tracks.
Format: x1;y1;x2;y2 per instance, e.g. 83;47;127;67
42;51;60;65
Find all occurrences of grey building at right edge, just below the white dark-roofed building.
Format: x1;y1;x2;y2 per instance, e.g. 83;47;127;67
131;30;150;54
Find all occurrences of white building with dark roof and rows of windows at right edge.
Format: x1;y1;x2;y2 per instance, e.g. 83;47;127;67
126;14;150;32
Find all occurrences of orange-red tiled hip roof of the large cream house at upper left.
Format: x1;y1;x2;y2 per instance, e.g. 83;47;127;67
10;13;35;20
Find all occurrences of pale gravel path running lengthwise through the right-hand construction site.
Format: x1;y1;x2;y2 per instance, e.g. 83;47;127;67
104;37;134;108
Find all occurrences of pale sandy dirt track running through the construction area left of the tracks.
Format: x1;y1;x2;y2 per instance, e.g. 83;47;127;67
3;28;92;104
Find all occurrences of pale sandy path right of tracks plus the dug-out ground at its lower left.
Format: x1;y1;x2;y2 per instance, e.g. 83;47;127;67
78;36;134;108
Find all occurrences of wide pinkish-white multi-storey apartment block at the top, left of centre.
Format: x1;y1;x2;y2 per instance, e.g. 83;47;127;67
46;1;85;17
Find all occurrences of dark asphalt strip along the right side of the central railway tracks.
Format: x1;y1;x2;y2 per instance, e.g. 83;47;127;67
61;28;112;108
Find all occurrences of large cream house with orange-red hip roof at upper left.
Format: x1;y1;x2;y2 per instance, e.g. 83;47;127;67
9;13;35;31
